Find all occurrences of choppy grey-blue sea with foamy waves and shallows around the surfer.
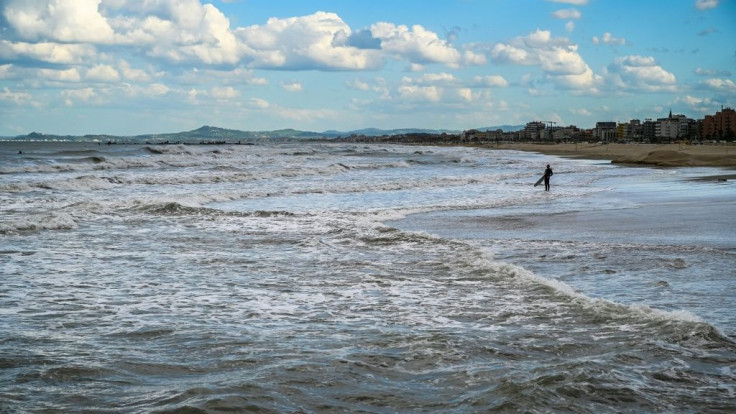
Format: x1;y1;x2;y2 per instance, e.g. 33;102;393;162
0;141;736;413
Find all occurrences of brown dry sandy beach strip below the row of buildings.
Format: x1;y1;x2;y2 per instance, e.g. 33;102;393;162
490;143;736;167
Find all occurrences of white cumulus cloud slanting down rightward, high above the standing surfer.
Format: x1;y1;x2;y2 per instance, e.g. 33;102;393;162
491;30;597;90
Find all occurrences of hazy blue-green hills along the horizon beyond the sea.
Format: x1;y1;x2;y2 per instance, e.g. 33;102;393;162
5;125;523;143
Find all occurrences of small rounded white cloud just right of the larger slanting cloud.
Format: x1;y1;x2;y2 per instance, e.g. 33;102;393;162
604;55;677;92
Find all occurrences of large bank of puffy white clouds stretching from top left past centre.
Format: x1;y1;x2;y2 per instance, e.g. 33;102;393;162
0;0;486;73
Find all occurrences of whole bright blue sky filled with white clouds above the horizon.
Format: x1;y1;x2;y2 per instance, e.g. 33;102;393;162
0;0;736;136
